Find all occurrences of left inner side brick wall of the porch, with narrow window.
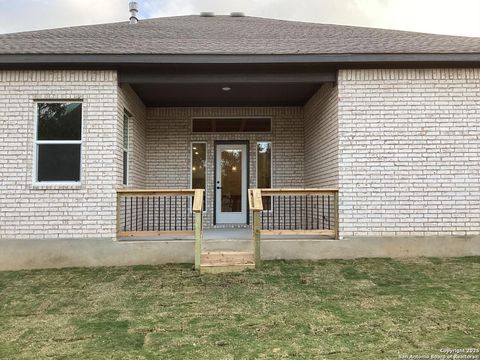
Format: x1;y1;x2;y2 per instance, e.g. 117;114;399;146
118;85;147;188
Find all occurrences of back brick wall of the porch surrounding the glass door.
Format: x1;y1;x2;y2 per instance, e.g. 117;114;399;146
146;107;304;227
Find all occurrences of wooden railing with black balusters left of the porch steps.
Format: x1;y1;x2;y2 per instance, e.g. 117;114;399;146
117;189;204;269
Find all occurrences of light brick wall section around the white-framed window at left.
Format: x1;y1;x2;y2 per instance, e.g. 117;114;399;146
0;71;121;239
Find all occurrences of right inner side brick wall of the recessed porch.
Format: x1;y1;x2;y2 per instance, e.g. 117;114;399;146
304;84;338;188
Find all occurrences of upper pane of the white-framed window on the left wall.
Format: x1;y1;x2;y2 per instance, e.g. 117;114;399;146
37;103;82;140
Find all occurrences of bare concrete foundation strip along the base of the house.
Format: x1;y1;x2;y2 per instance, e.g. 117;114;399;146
0;236;480;271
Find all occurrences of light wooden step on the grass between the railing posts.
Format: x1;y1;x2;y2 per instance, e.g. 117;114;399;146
200;251;255;273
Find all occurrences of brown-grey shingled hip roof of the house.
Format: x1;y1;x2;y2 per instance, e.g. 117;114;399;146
0;15;480;55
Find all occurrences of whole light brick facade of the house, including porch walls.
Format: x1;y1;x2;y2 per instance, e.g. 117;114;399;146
0;14;480;267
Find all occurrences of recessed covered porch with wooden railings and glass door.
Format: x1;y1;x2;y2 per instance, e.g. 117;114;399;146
117;65;338;270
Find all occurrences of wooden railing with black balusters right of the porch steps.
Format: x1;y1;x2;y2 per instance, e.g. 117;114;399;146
248;189;338;264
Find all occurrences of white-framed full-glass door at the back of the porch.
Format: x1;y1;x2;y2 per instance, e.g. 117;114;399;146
215;144;248;224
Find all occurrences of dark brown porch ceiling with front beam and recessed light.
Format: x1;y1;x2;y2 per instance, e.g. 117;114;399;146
119;67;336;107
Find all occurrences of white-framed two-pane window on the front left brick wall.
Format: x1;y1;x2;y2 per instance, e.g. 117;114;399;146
35;102;82;182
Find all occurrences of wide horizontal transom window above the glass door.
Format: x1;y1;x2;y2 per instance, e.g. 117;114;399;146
192;118;272;133
